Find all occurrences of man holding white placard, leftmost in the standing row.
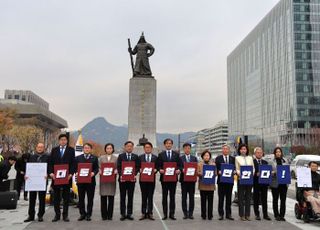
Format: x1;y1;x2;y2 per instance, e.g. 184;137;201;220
24;143;49;222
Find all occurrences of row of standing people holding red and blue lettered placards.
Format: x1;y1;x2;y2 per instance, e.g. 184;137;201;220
26;134;300;222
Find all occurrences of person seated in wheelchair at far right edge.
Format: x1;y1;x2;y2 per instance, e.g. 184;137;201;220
303;161;320;217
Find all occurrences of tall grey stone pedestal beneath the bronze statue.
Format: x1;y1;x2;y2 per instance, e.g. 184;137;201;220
128;76;157;147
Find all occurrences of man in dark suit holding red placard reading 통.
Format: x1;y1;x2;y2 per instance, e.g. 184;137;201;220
75;143;99;221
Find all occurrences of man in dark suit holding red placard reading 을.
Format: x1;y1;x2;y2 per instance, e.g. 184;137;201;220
179;143;198;219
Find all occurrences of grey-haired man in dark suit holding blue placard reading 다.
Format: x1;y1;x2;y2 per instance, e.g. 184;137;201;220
253;147;271;220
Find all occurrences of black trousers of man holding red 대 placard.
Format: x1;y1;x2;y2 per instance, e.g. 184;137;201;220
53;185;70;217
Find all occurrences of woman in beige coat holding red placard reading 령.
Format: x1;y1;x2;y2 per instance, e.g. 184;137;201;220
99;143;117;220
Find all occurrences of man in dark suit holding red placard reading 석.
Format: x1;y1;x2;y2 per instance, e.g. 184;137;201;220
139;142;157;220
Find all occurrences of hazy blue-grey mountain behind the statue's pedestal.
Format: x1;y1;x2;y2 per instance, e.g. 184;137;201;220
72;117;195;148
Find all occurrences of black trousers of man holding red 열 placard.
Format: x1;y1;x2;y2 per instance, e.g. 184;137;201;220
161;182;177;216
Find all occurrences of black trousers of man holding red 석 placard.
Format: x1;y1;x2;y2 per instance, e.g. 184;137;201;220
140;182;155;215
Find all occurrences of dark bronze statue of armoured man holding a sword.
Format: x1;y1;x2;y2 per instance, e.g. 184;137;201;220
128;33;154;77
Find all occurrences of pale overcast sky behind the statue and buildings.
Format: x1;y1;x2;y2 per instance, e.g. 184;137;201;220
0;0;278;133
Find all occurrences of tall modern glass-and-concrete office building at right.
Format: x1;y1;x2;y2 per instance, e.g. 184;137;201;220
227;0;320;154
